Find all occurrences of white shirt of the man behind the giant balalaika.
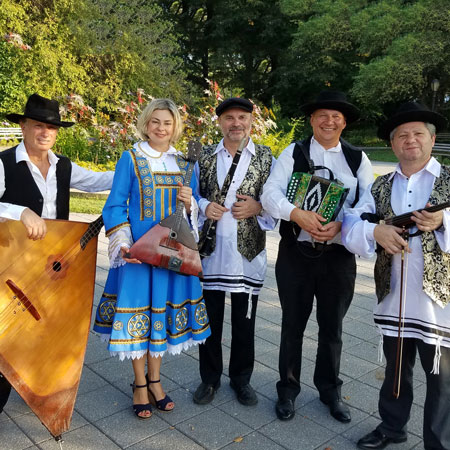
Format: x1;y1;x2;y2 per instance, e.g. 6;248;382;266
0;141;114;220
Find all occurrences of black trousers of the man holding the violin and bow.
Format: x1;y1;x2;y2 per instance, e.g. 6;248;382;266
378;336;450;450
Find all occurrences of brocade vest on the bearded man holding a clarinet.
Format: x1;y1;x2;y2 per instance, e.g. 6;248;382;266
198;144;272;261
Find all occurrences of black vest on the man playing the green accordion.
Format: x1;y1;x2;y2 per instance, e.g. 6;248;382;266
280;136;362;242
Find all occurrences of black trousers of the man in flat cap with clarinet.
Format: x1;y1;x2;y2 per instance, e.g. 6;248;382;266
199;290;258;386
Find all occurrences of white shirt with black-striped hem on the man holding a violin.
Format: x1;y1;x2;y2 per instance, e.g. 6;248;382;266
342;158;450;347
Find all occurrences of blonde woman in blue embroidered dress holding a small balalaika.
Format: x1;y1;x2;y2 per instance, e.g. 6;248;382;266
94;99;210;419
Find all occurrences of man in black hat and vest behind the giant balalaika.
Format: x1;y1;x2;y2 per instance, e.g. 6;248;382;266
0;94;114;412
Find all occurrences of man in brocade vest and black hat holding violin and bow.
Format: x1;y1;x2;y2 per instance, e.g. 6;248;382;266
342;102;450;450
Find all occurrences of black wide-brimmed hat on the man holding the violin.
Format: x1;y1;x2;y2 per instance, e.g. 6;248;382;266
377;102;447;141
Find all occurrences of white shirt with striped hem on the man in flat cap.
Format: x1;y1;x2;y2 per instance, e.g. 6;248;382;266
196;139;276;295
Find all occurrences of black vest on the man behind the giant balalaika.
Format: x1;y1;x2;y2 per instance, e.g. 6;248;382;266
0;146;72;220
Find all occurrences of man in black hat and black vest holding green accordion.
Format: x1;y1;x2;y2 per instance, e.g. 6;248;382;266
262;91;373;422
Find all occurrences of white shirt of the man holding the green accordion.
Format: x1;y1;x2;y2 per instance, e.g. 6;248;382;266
261;137;373;244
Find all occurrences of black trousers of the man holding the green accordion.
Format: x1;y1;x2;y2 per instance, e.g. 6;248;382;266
275;239;356;402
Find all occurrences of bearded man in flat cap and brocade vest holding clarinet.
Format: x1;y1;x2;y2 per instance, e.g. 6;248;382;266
194;98;276;405
